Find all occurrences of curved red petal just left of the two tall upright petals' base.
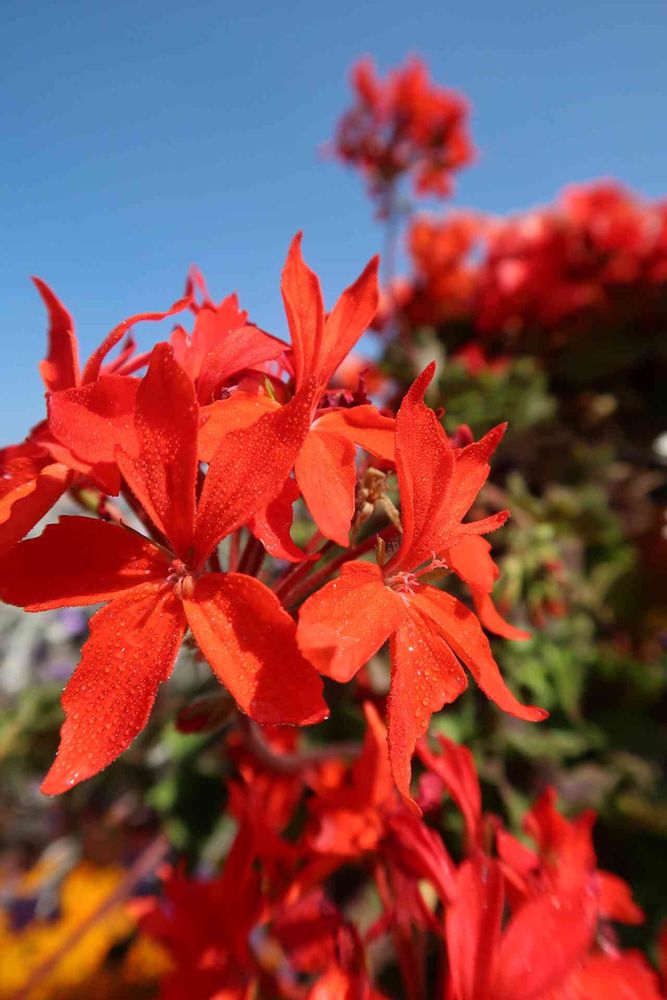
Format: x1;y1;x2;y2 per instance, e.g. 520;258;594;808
197;324;288;403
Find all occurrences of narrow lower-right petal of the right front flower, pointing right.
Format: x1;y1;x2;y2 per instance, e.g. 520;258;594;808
411;587;549;722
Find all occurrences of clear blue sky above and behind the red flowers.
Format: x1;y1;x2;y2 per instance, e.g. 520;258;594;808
0;0;667;443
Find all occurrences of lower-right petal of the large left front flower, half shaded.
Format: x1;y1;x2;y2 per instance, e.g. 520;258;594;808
184;573;328;726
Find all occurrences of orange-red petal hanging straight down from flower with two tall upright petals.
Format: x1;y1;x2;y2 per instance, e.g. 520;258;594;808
294;430;357;548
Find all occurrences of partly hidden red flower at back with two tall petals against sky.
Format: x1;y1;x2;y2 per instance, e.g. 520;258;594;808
200;234;394;559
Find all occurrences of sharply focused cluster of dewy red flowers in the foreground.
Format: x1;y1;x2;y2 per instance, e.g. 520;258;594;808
0;237;546;800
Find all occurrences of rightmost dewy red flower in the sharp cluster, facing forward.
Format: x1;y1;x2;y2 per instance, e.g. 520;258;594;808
298;365;546;797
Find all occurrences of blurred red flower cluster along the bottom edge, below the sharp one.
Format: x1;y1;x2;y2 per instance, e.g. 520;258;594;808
134;716;661;1000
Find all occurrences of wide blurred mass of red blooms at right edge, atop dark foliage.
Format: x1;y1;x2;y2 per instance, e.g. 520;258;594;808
396;181;667;352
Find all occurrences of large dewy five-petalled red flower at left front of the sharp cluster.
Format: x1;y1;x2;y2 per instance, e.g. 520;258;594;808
0;344;326;794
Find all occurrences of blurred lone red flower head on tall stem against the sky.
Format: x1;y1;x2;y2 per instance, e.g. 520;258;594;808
333;58;473;214
